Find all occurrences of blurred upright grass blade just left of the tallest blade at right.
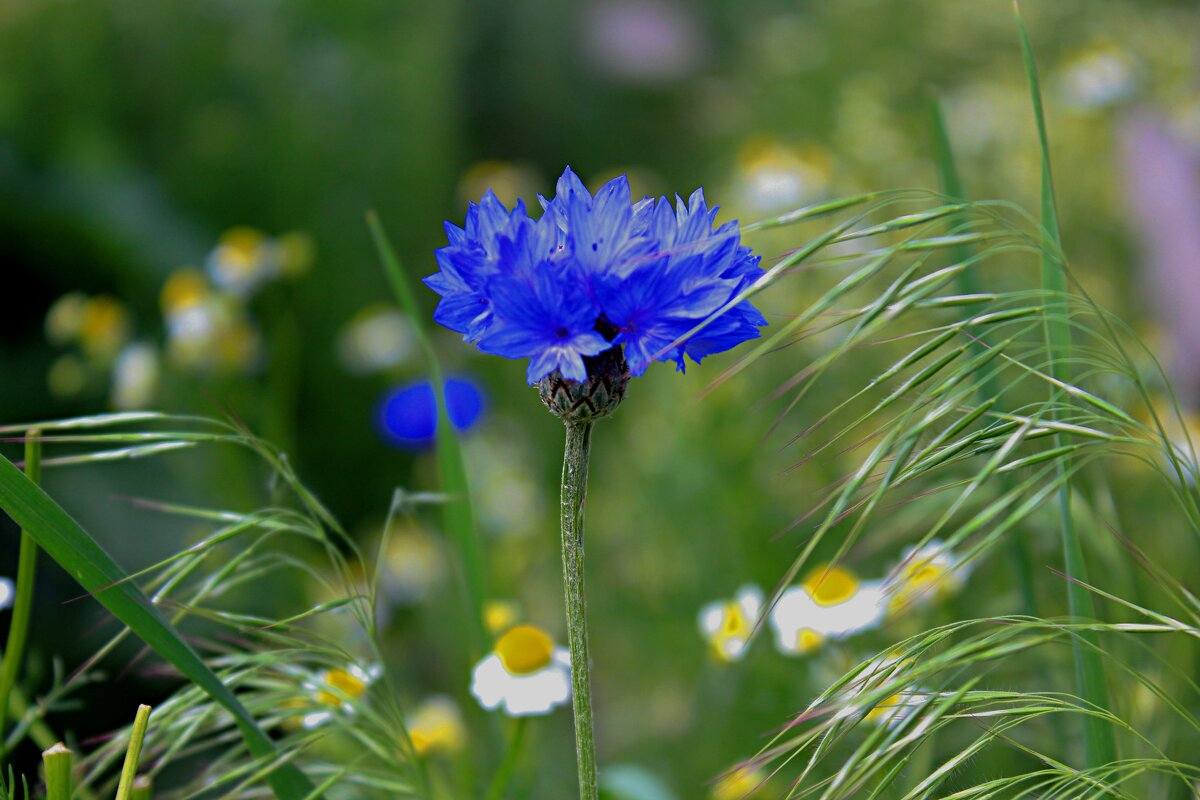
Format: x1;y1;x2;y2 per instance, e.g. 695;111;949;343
929;95;1038;615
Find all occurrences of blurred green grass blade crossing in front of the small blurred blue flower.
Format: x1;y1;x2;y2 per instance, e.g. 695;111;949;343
367;212;487;655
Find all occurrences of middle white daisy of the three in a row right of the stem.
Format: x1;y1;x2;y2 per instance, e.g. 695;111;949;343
770;565;886;655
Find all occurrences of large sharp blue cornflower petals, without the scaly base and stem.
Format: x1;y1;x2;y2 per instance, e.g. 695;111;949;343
425;168;767;384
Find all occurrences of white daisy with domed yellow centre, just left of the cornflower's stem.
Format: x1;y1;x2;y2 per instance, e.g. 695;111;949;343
470;625;571;717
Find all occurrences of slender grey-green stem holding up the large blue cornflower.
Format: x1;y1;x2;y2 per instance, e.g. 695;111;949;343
560;421;598;800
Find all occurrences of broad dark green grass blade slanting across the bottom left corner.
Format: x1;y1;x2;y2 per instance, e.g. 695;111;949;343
0;457;312;800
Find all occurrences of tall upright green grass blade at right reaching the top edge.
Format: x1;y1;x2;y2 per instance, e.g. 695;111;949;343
1013;0;1117;769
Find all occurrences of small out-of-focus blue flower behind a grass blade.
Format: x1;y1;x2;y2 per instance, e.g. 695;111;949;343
378;378;486;450
